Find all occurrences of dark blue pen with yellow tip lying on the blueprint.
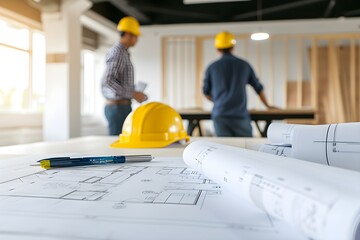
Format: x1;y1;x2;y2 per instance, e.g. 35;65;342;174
38;155;153;169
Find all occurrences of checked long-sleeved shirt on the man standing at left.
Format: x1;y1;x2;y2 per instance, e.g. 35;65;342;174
101;42;134;100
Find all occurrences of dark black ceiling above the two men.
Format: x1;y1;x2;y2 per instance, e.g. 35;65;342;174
91;0;360;25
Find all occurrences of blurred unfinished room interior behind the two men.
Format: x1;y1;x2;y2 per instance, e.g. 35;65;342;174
0;0;360;145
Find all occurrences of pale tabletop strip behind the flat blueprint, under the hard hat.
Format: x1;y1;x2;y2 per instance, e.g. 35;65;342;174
0;136;266;159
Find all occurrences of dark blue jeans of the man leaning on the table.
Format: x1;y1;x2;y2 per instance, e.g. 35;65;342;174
213;117;252;137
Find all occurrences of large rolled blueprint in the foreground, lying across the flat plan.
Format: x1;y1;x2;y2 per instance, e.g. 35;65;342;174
183;141;360;240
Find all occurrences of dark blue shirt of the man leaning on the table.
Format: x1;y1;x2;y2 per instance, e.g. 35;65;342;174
203;53;263;118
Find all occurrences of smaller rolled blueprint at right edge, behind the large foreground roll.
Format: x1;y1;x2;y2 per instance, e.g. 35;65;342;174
262;122;360;171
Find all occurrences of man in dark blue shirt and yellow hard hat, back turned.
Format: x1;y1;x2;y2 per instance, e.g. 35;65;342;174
203;32;274;137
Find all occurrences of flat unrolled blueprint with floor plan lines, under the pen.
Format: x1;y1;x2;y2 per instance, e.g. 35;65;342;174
0;156;307;240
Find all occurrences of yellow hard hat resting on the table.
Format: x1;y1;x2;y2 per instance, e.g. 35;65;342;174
111;102;190;148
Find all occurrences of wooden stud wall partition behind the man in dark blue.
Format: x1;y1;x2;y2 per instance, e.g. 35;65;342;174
162;33;360;124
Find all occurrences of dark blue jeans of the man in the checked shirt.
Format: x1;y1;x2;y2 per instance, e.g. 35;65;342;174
105;104;131;135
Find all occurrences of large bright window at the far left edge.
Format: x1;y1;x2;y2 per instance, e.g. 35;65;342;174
0;16;45;112
